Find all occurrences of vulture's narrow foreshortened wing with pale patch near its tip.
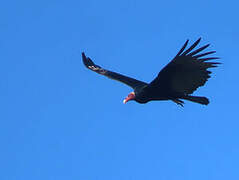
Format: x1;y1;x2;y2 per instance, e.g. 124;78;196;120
82;53;147;89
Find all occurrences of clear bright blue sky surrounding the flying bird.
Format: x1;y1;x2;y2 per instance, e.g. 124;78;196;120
0;0;239;180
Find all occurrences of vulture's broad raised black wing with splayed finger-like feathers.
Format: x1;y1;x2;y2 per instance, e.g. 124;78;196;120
149;38;220;94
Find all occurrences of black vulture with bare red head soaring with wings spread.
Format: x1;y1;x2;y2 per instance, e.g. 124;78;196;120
82;38;220;106
